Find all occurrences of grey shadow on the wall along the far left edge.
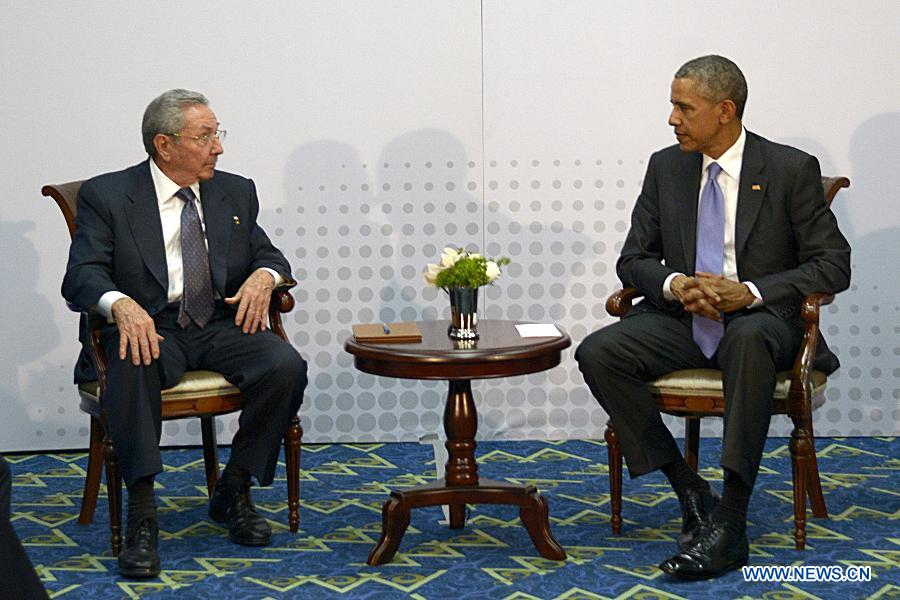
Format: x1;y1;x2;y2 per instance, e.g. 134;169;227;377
0;221;60;446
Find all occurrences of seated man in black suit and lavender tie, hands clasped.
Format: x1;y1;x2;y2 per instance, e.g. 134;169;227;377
575;56;850;579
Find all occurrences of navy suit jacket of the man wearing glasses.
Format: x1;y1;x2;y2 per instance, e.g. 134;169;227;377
62;161;291;380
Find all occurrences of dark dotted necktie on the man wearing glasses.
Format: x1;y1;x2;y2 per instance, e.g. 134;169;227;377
175;187;215;328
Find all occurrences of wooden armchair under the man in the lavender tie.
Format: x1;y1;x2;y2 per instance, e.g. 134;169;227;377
605;177;850;550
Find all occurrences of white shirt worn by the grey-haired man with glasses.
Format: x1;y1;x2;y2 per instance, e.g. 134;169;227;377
97;158;282;318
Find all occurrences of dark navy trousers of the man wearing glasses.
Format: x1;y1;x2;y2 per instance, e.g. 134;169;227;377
101;304;307;485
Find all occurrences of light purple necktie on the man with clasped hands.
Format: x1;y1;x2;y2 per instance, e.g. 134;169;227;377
693;163;725;358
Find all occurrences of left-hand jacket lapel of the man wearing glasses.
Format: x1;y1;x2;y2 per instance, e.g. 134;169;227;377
125;162;169;293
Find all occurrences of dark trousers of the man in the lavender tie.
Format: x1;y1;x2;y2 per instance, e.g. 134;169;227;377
575;305;803;488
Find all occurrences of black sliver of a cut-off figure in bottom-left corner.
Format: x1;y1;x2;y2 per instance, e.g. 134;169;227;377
0;456;47;600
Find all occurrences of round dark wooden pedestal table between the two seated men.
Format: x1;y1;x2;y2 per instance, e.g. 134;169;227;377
344;319;572;566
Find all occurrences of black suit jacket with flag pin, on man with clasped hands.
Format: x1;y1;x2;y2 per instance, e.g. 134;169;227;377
616;131;850;371
